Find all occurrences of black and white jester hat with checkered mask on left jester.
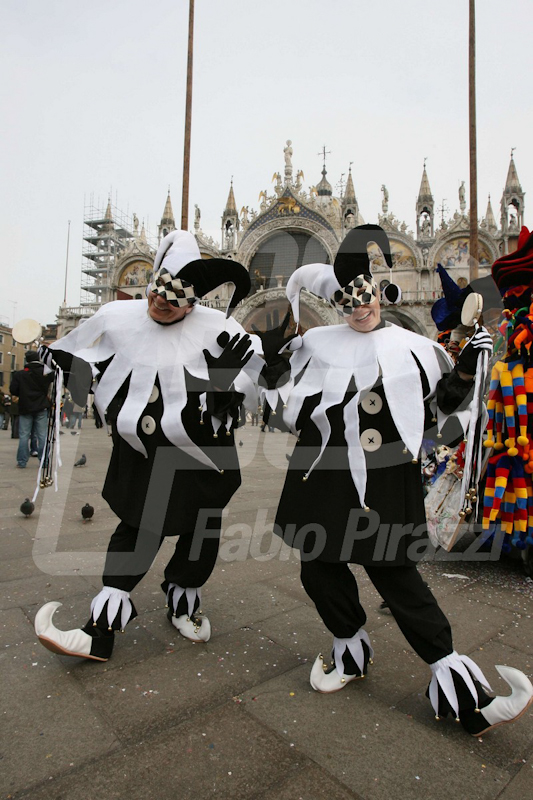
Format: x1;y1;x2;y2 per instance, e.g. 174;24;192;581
147;231;251;317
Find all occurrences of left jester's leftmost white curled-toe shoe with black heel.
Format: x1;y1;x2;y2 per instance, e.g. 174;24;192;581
35;602;114;661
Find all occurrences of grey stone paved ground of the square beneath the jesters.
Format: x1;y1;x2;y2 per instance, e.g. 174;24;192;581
0;421;533;800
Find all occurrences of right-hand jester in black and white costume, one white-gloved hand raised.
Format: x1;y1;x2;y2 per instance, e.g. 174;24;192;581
260;225;533;736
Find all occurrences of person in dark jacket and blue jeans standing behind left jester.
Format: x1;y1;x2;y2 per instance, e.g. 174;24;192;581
9;350;54;469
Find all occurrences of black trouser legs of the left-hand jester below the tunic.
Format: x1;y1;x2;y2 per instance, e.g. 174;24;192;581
103;517;221;592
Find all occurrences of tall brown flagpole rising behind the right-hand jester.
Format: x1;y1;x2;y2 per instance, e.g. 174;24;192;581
468;0;479;282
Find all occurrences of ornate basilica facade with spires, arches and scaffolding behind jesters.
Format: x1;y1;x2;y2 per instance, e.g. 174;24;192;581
63;141;524;338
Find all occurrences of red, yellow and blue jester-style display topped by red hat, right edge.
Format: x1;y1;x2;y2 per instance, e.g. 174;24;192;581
483;227;533;552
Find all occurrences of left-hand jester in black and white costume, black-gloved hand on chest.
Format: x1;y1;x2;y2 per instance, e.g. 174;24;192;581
35;231;263;661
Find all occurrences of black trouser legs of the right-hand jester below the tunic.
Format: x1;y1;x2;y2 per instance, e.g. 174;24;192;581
301;560;453;664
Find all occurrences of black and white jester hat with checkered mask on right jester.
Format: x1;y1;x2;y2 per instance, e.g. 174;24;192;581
287;225;401;324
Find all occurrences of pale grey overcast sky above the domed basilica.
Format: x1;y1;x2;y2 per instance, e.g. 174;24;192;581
0;0;533;324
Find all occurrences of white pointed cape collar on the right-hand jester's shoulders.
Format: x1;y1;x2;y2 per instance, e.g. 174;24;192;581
284;324;453;508
